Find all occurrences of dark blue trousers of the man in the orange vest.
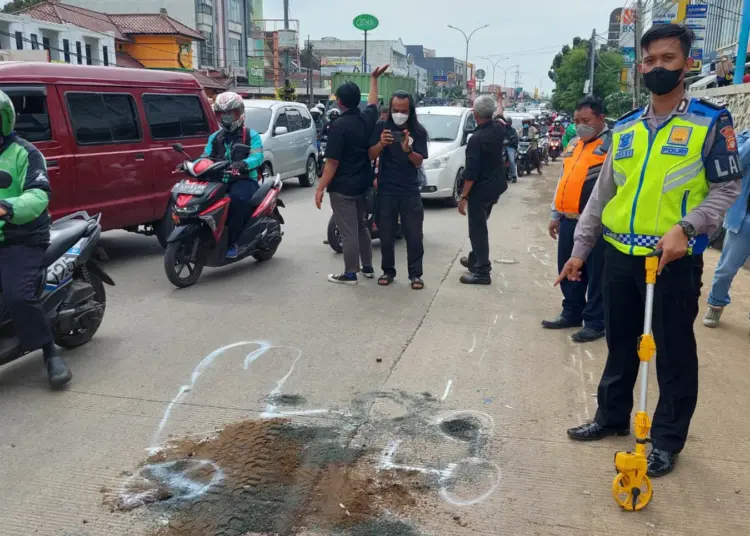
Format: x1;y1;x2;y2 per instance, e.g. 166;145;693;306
557;218;604;331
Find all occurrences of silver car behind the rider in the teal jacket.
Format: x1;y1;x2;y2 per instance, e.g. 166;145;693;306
245;99;318;187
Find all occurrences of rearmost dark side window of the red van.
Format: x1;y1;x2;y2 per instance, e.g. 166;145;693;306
143;95;209;140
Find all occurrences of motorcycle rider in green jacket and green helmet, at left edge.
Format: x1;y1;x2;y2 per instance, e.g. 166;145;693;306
0;91;73;389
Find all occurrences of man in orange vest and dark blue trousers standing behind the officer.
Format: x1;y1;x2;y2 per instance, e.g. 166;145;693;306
542;96;612;342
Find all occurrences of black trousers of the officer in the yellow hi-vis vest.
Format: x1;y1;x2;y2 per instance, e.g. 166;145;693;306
595;244;703;452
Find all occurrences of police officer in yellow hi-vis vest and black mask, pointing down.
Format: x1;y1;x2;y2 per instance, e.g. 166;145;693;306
558;24;742;477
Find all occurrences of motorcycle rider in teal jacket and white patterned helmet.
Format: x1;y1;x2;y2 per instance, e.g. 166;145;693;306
201;91;263;259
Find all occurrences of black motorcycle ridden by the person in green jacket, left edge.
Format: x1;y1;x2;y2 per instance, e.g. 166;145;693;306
0;211;115;365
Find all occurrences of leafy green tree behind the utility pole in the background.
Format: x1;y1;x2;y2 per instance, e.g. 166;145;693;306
550;37;622;112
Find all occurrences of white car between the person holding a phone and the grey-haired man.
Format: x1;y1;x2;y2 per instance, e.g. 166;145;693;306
417;106;477;206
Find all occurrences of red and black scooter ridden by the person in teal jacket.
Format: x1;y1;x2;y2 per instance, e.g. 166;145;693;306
164;143;284;288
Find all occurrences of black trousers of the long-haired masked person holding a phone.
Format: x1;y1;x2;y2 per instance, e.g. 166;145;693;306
377;192;424;279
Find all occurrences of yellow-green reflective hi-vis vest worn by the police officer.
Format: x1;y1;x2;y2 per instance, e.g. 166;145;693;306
602;99;721;256
